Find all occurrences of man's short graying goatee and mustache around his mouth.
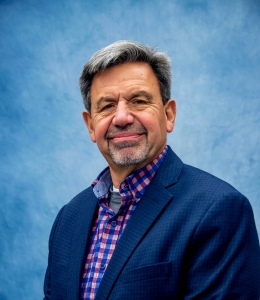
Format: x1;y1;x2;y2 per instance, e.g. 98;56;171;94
106;124;149;166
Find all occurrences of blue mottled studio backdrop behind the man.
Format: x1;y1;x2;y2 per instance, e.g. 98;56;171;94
0;0;260;300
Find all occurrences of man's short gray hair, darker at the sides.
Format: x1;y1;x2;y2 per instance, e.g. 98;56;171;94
79;41;171;112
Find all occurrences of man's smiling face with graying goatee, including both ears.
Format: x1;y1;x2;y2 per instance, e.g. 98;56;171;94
83;62;176;169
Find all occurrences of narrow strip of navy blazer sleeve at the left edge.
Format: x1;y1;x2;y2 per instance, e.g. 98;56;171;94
43;206;65;300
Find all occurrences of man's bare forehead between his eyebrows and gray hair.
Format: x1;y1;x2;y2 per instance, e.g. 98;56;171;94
91;62;159;96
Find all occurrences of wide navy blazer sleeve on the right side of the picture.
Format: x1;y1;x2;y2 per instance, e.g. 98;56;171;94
184;192;260;300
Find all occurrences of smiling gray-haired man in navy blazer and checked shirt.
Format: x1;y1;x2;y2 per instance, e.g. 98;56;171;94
44;41;260;300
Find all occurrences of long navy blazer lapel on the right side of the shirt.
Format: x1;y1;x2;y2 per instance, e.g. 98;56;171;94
95;149;182;300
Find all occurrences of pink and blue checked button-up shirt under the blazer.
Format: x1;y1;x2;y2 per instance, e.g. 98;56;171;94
81;146;168;300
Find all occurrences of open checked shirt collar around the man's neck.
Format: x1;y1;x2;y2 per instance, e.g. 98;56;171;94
92;146;168;200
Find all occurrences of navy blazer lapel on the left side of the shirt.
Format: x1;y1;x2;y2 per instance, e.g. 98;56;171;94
67;188;98;299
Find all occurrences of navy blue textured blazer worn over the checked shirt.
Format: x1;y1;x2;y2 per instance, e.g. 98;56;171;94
44;149;260;300
